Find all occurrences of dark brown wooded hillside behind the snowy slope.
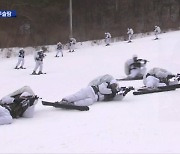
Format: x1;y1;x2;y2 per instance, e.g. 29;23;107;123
0;0;180;48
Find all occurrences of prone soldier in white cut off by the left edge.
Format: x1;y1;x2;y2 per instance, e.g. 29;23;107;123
0;86;38;125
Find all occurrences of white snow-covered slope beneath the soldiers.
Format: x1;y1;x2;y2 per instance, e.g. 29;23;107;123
0;31;180;153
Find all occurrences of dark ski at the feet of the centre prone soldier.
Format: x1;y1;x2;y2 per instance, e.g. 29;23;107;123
42;101;89;111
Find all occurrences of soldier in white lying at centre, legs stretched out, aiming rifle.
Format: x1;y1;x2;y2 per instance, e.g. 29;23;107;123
58;74;134;106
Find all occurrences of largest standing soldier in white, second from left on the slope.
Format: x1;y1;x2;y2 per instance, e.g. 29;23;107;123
32;49;46;75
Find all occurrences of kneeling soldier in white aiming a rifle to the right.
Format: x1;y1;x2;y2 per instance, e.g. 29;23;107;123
124;55;148;79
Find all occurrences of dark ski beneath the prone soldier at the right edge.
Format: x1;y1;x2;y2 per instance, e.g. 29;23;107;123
133;86;176;95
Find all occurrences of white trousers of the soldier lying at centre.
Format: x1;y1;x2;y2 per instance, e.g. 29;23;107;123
63;86;98;106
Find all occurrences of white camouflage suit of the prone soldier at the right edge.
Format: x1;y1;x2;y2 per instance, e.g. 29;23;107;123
143;67;178;88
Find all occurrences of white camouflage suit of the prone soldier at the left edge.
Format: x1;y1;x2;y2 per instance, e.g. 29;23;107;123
0;86;38;125
